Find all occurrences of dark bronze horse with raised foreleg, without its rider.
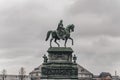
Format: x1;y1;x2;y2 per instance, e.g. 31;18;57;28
46;24;75;47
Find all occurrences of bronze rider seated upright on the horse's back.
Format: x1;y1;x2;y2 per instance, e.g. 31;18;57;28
57;20;65;40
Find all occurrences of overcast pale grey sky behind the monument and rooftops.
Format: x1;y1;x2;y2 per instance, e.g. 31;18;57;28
0;0;120;75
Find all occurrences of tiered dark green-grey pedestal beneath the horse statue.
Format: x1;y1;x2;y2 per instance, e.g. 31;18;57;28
40;47;78;80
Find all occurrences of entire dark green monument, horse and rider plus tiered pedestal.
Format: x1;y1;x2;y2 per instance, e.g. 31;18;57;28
29;20;78;80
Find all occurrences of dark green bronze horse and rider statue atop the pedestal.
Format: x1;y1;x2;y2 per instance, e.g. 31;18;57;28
46;20;75;47
